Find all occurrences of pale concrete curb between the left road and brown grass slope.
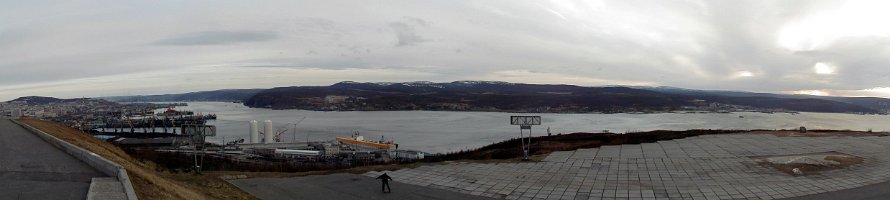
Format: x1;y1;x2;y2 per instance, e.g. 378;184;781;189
10;119;138;200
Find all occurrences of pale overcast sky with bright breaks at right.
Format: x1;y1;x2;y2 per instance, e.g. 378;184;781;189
0;0;890;100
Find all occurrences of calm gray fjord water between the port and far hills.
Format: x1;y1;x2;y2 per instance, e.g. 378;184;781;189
177;102;890;153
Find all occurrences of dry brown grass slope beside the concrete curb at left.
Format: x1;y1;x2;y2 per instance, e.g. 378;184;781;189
20;119;257;200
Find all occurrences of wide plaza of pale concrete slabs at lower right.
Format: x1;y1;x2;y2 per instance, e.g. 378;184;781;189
365;133;890;199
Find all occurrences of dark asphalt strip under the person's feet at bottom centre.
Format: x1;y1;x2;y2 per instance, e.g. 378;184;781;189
229;174;490;200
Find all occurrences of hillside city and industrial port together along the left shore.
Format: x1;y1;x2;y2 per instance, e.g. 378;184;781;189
0;97;427;171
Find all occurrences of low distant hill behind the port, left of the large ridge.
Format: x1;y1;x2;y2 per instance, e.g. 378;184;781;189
101;89;264;102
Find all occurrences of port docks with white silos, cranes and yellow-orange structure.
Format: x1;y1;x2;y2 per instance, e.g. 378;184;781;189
110;108;426;170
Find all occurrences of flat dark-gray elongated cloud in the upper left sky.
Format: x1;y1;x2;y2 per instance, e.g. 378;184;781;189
154;31;278;46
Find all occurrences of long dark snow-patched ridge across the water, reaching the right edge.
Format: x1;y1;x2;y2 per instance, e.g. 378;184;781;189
244;81;887;113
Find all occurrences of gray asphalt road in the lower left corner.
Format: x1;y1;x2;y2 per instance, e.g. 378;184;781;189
0;118;105;199
